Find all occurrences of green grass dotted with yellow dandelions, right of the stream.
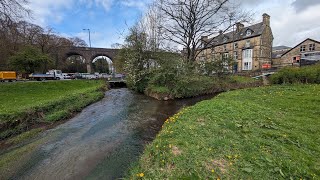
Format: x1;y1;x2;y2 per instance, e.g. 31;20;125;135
127;85;320;179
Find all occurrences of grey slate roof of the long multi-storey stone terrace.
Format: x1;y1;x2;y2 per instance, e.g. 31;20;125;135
206;22;266;47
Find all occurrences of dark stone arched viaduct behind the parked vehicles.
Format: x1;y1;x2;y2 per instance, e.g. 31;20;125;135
65;47;120;73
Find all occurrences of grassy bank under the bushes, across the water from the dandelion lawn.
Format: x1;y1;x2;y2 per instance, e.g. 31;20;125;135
145;75;262;100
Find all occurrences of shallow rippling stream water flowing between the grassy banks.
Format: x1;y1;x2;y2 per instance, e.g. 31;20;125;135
5;88;213;180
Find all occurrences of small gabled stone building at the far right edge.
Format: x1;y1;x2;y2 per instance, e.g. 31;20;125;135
278;38;320;68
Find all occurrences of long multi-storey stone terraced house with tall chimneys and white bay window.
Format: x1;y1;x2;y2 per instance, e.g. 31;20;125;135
197;14;273;72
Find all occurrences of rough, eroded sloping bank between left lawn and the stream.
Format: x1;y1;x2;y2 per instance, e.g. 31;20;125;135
0;83;109;144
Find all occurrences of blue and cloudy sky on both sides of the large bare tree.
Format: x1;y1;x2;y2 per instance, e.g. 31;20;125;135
28;0;320;48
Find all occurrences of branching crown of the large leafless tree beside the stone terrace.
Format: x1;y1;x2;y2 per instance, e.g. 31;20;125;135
158;0;248;62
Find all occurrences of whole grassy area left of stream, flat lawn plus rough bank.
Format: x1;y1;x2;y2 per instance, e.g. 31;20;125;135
0;80;105;139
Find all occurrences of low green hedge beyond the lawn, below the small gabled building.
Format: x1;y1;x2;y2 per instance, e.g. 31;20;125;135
270;64;320;84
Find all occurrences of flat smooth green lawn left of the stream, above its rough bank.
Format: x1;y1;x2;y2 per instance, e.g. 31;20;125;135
0;81;104;113
